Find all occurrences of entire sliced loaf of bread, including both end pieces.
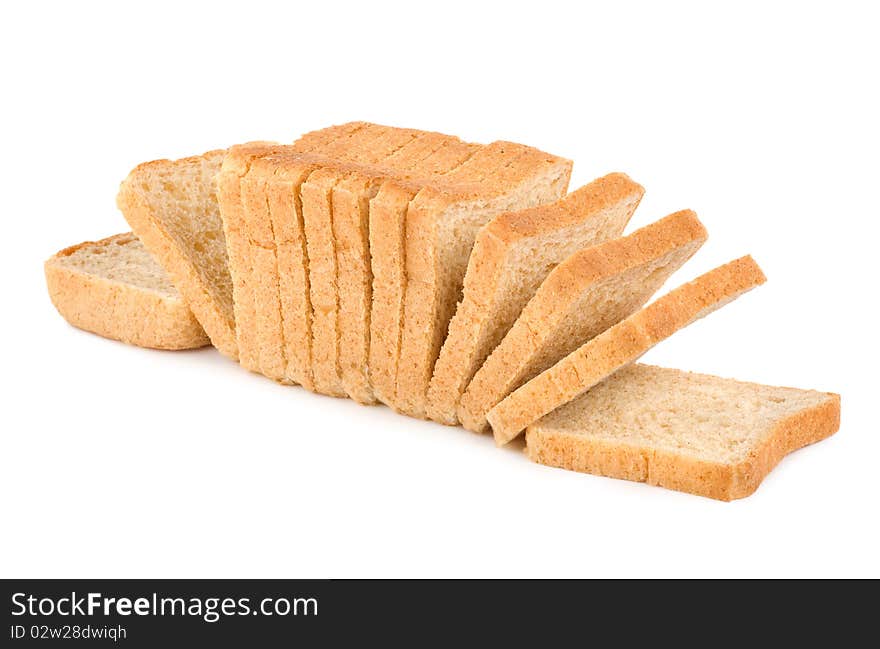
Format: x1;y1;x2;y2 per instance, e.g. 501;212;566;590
46;122;840;500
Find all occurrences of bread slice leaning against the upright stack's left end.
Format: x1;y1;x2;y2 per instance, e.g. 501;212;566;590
117;150;238;358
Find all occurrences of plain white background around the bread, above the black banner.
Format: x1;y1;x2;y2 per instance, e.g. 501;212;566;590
0;1;880;577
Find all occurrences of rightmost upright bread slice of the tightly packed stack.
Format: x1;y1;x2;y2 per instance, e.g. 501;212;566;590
394;142;571;418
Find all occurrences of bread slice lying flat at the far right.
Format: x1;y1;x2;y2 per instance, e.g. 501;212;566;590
526;364;840;500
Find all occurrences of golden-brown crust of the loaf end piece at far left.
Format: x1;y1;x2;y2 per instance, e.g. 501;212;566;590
44;233;210;350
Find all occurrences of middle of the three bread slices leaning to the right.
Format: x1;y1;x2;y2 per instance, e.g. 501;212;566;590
458;210;706;432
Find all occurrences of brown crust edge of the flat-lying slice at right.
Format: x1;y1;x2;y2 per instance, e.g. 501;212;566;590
526;364;840;501
